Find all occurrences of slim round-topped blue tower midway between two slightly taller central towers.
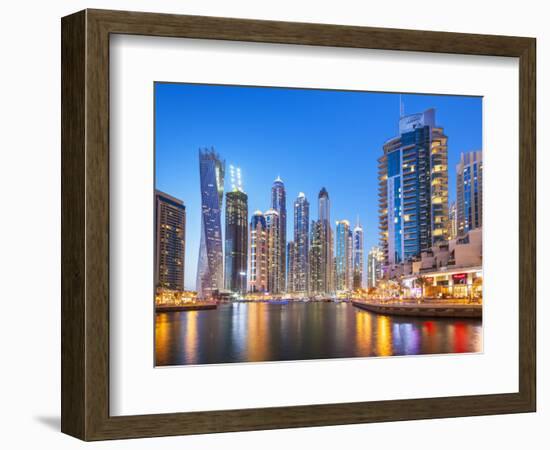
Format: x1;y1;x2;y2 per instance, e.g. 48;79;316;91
294;192;309;293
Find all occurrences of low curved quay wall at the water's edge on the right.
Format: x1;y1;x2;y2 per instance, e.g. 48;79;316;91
352;300;483;319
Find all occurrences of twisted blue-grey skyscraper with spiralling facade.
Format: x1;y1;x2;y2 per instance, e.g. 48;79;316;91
197;148;225;298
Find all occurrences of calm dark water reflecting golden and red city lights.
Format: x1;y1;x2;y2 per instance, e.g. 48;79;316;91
155;302;483;366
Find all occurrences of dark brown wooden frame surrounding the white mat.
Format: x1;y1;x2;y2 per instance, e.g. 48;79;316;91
61;10;536;440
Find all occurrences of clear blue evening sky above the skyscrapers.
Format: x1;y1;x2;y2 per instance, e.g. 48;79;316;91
155;83;482;289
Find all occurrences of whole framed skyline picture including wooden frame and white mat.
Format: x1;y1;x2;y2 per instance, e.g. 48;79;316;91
62;10;536;440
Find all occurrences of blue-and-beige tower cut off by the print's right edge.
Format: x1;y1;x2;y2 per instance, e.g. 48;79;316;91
456;151;483;236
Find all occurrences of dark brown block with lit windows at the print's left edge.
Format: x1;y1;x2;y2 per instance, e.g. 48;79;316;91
155;191;185;291
